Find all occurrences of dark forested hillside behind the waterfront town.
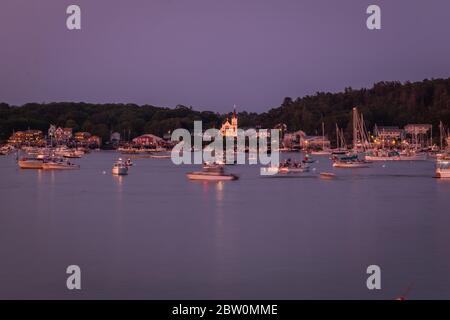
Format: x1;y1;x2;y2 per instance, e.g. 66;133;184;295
0;78;450;140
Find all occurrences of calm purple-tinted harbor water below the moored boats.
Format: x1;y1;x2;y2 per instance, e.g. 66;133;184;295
0;151;450;299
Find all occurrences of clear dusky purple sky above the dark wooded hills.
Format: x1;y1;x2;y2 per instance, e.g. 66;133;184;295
0;0;450;112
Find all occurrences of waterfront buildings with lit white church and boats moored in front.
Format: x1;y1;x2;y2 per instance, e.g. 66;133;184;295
0;107;450;181
